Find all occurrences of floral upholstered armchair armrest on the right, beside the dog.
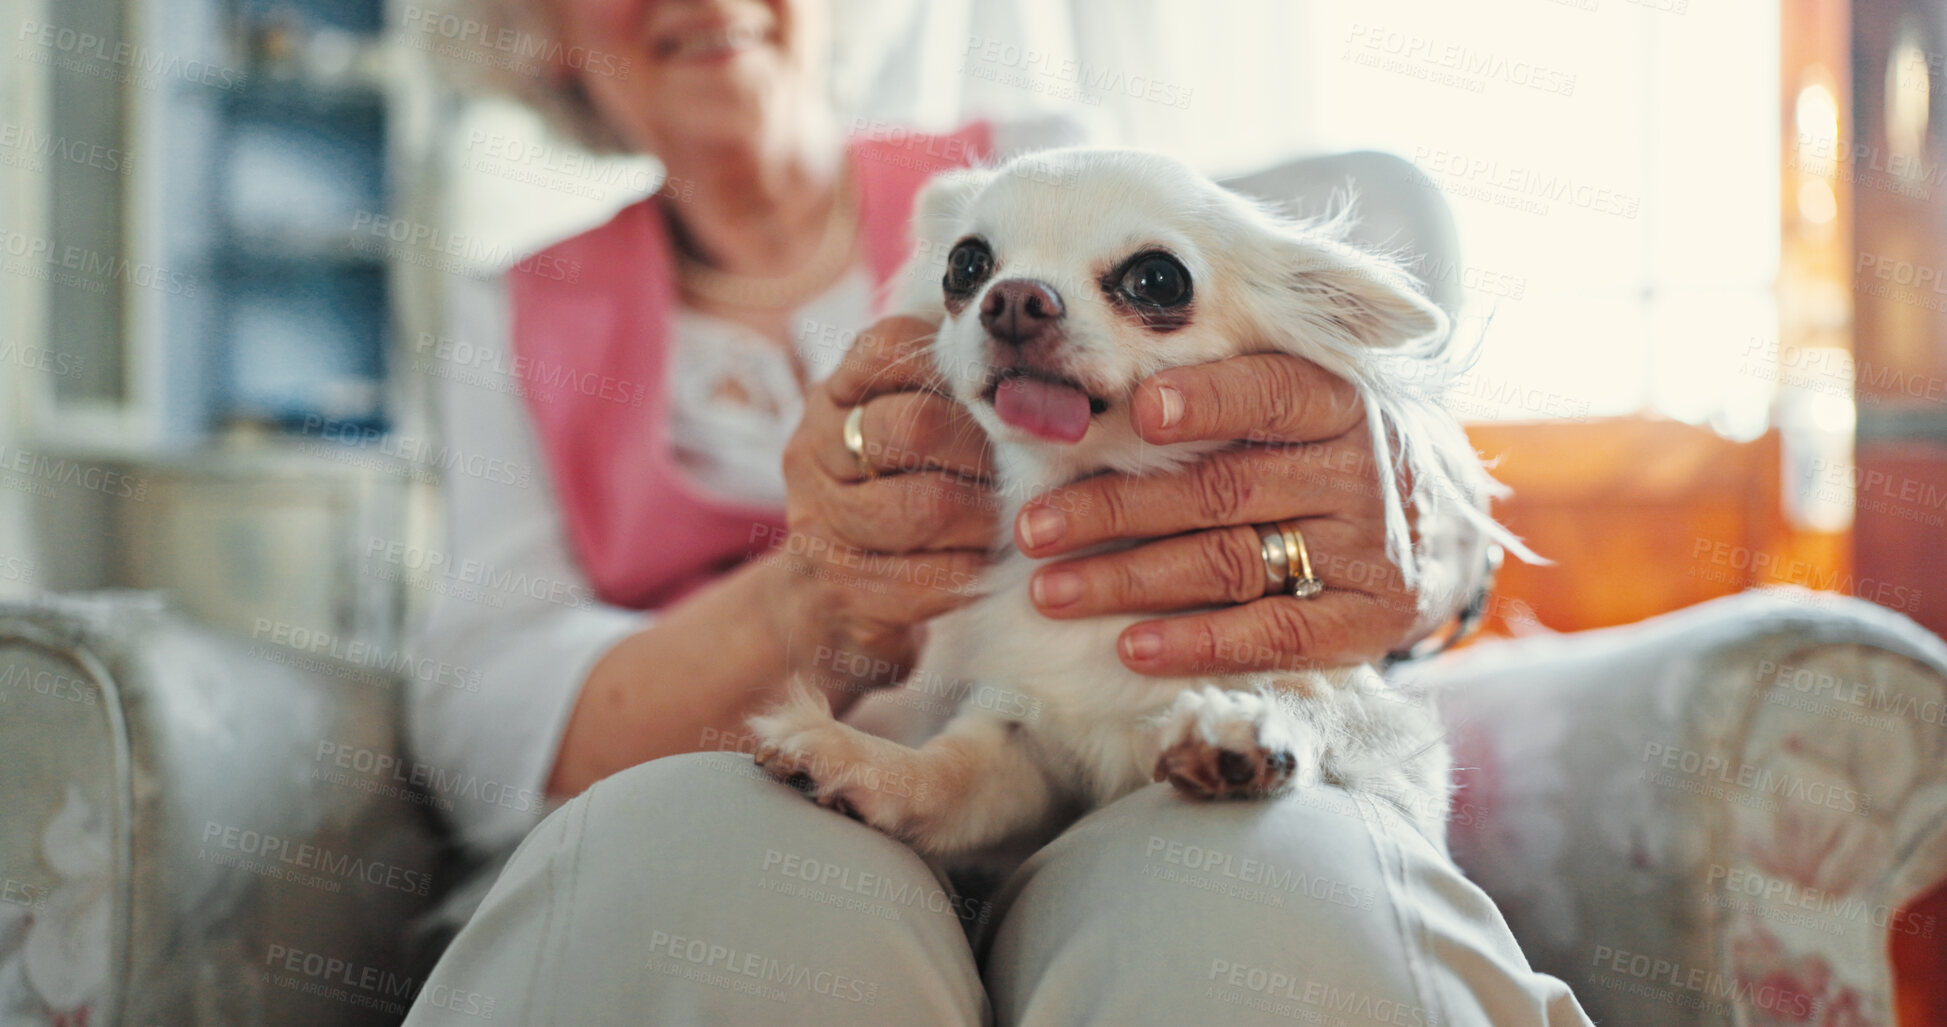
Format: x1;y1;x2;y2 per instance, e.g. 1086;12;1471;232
1421;590;1947;1025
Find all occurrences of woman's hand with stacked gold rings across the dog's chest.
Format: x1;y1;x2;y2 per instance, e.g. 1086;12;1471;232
1014;355;1462;674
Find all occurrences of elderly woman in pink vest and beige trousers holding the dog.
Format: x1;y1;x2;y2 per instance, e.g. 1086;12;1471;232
409;0;1583;1025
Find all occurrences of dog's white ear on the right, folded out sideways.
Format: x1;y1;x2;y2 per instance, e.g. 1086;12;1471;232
1281;236;1449;351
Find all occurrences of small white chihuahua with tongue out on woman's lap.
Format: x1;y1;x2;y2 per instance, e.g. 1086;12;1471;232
752;150;1505;856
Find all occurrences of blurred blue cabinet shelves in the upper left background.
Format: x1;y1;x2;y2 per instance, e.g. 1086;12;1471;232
202;0;389;431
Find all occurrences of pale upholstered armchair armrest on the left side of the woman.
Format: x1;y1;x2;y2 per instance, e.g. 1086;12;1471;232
0;594;438;1025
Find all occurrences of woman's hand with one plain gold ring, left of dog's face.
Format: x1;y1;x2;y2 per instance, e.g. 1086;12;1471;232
775;318;997;709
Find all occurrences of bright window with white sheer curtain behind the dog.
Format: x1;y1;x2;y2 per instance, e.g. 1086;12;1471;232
839;0;1780;430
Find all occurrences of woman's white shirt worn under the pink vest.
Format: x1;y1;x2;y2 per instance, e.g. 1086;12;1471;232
407;267;872;850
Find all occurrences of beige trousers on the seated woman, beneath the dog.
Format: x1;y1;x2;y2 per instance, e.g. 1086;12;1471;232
407;754;1589;1027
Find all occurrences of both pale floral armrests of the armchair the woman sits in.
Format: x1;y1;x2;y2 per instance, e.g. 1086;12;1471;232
0;592;1947;1027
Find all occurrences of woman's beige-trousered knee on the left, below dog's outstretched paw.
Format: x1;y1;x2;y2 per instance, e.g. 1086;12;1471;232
410;754;983;1023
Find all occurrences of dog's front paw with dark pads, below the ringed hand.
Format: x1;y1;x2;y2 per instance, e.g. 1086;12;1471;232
1153;688;1318;799
